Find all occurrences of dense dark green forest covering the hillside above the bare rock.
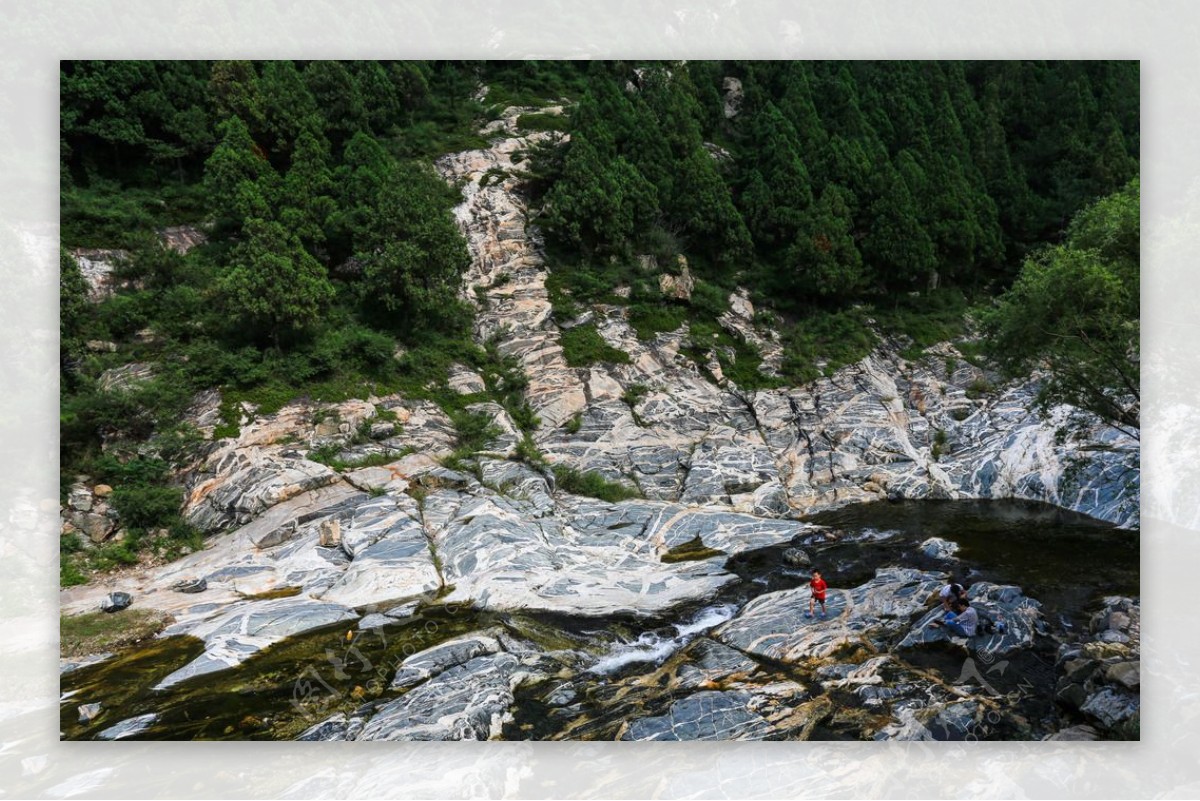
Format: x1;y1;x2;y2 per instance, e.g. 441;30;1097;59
60;61;1140;584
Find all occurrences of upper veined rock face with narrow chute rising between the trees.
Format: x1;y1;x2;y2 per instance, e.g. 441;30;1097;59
429;108;1140;528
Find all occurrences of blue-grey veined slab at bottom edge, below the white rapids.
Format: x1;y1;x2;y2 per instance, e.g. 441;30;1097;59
620;691;770;740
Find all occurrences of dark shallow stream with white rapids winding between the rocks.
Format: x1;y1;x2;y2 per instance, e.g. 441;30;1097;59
60;501;1139;740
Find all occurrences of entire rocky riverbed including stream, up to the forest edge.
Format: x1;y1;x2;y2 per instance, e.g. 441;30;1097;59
61;109;1140;740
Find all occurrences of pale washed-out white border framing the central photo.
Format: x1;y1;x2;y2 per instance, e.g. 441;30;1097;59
0;0;1200;797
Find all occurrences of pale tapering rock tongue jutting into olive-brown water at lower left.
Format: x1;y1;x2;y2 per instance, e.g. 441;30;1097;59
155;596;358;689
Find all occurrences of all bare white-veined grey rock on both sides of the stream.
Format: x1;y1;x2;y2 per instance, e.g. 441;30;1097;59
61;108;1140;740
